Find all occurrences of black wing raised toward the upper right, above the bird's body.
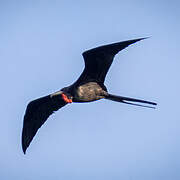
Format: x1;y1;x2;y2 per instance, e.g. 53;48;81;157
76;38;145;84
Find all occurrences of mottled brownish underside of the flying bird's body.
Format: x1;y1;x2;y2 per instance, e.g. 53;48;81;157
74;82;107;102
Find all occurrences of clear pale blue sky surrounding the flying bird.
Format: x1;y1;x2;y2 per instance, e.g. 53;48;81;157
0;0;180;180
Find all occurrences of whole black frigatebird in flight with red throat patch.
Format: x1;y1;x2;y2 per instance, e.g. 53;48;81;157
22;38;156;153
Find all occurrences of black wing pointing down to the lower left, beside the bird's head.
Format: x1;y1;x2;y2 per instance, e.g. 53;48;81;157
22;95;67;153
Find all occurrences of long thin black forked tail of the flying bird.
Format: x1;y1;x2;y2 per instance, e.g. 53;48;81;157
105;94;157;109
